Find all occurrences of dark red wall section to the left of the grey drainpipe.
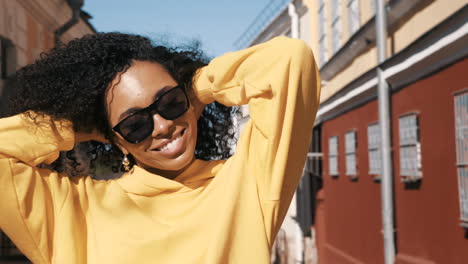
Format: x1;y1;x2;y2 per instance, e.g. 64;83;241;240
317;95;383;264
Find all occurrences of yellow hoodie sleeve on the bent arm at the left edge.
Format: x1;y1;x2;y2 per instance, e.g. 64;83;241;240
0;114;74;263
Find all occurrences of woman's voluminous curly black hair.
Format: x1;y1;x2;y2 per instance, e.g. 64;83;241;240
11;32;238;175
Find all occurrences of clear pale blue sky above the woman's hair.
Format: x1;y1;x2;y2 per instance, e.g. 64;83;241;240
83;0;270;56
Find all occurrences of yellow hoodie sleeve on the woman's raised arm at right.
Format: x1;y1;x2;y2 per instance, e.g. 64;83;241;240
194;37;320;218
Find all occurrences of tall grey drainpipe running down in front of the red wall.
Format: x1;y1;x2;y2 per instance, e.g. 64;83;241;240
375;0;395;264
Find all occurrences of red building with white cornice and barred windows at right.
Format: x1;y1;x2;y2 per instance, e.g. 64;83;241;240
314;4;468;264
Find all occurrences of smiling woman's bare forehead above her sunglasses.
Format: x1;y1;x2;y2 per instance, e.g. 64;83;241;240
106;61;177;124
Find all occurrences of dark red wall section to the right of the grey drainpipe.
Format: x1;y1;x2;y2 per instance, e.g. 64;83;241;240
392;59;468;264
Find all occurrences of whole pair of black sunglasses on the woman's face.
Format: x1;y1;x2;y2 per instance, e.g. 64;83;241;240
112;85;190;144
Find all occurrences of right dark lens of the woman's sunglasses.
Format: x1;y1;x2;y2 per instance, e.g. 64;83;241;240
156;88;189;120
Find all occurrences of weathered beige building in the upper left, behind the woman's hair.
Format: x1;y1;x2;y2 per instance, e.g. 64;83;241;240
0;0;95;116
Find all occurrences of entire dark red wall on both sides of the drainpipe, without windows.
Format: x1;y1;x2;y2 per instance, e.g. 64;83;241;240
317;59;468;264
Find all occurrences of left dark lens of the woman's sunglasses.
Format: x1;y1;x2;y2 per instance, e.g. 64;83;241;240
120;113;153;143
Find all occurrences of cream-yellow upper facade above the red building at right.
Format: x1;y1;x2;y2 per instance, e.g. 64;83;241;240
305;0;468;102
